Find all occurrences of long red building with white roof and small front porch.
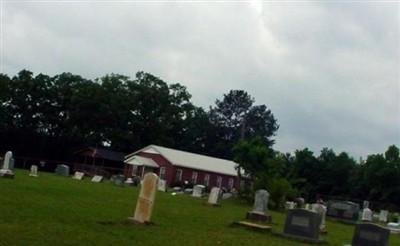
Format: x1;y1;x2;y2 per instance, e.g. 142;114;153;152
125;145;239;190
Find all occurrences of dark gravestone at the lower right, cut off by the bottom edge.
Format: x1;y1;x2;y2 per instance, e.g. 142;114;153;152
351;223;390;246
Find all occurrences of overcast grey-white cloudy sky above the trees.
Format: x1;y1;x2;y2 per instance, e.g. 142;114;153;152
0;0;400;160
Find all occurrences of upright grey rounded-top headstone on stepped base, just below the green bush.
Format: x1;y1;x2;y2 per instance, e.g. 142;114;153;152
246;190;271;222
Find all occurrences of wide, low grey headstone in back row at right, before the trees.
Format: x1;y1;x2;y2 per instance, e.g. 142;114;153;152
326;200;360;223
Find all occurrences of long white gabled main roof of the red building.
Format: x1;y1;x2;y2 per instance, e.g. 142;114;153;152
125;145;238;176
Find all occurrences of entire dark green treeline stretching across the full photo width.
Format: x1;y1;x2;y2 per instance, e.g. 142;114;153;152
0;70;400;209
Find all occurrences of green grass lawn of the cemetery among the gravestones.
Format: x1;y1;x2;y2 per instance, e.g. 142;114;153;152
0;169;400;246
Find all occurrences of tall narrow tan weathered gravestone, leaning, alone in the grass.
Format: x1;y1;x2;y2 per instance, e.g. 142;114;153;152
128;173;158;223
